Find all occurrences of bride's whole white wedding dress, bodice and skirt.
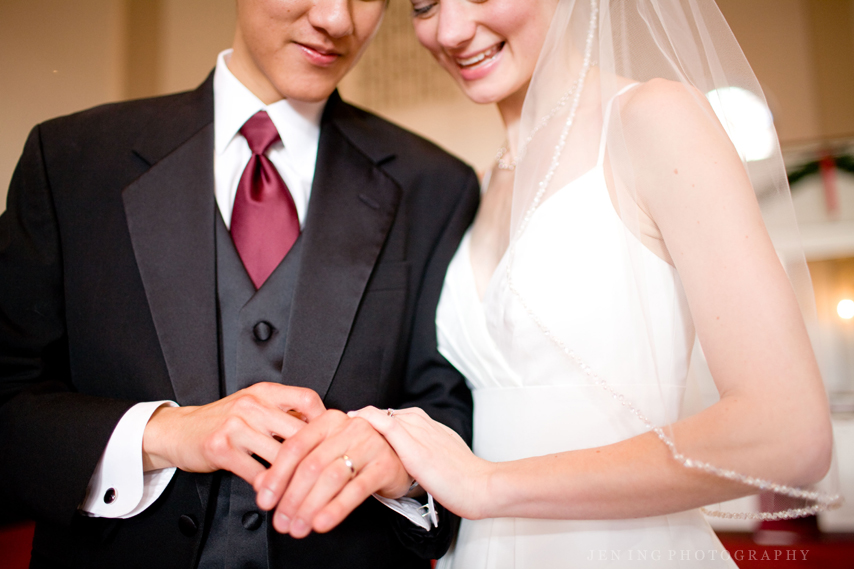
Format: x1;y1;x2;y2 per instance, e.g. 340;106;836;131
437;91;735;569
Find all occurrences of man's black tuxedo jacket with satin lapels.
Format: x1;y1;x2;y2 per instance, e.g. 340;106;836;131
0;78;478;569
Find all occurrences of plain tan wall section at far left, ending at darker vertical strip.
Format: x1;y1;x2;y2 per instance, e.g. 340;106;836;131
0;0;124;211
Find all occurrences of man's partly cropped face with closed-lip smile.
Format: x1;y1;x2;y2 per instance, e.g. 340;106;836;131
228;0;387;104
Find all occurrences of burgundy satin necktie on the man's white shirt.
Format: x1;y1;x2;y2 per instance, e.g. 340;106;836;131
231;111;300;289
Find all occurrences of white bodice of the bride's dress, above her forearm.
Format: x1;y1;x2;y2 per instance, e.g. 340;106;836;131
437;161;694;460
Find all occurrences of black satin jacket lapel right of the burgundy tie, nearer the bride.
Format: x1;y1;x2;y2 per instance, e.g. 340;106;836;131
282;93;401;397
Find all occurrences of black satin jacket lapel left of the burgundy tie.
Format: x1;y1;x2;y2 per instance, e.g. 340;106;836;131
123;80;219;405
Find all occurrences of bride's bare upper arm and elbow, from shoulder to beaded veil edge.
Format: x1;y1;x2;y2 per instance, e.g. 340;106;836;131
623;80;832;486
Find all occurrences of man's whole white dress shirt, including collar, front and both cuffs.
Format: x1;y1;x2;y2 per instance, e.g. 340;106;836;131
80;50;438;529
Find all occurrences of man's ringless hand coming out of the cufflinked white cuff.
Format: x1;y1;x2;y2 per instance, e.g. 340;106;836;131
142;383;326;484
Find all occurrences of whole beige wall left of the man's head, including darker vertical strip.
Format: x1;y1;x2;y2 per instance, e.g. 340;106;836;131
0;0;235;211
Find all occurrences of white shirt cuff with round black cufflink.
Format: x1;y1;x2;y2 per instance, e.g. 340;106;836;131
80;401;178;518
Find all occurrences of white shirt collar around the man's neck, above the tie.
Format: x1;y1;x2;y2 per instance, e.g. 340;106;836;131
214;49;326;155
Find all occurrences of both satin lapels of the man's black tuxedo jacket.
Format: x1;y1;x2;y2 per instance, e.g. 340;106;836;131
123;84;401;405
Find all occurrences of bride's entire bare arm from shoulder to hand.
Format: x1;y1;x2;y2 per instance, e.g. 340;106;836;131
352;81;832;519
